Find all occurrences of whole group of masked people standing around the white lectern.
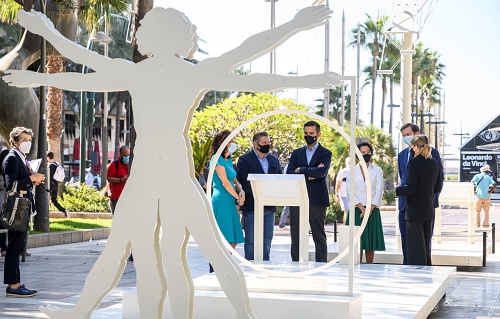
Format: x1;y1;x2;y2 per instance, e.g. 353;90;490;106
211;121;444;265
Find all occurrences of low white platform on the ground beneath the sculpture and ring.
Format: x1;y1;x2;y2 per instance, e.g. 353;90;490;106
123;262;455;319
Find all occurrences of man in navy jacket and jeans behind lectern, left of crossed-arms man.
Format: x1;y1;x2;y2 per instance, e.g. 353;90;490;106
237;132;283;260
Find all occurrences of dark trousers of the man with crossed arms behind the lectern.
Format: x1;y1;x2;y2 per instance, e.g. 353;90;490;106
290;206;328;262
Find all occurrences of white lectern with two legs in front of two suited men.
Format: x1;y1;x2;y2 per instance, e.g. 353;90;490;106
248;174;309;262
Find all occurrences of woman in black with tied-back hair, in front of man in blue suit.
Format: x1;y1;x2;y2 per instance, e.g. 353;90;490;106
396;135;443;266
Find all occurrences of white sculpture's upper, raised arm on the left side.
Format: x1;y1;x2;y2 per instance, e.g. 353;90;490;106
17;9;126;71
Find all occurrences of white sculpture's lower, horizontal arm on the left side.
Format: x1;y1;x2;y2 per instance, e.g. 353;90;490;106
2;70;128;92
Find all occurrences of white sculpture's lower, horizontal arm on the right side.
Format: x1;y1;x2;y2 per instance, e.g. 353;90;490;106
210;72;341;92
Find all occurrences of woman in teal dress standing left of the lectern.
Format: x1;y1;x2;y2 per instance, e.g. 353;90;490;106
210;130;245;248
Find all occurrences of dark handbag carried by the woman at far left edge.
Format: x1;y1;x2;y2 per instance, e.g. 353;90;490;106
0;181;31;232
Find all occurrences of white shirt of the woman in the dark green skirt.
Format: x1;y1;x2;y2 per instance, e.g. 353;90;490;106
346;163;384;207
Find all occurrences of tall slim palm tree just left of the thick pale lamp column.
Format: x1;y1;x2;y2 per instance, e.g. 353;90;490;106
349;14;389;125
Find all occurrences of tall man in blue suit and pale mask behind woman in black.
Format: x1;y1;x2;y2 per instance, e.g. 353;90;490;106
398;123;444;265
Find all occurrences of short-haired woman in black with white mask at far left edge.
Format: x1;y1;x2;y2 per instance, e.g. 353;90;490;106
2;127;45;297
